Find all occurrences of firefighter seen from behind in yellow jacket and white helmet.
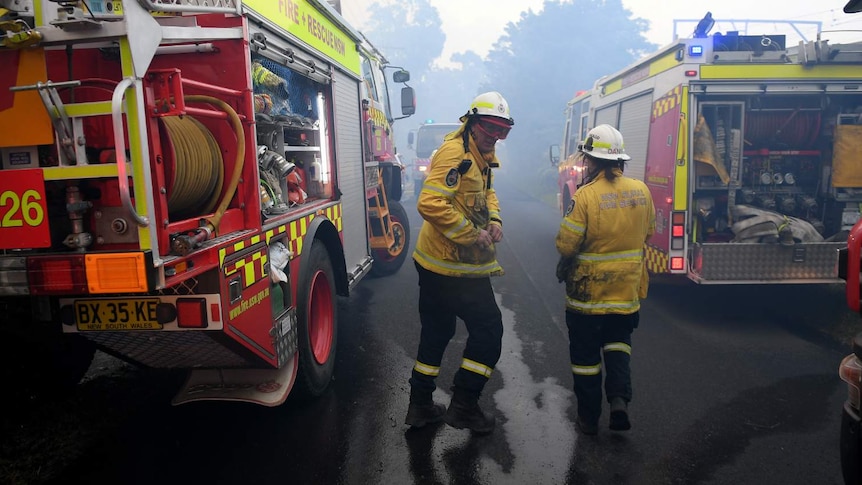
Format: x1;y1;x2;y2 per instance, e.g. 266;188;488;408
556;125;655;435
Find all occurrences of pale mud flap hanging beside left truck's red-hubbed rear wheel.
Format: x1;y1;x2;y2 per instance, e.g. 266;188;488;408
171;353;299;407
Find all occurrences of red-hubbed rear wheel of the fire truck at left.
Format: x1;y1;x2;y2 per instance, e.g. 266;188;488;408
296;239;338;397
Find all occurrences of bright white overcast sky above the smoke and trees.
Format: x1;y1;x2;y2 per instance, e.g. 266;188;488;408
341;0;862;65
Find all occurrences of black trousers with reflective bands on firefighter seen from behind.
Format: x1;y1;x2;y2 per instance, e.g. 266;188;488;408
566;311;640;422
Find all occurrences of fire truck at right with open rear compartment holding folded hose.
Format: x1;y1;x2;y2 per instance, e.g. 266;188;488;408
551;23;862;284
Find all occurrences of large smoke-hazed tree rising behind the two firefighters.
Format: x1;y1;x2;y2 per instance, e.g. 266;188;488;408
484;0;655;163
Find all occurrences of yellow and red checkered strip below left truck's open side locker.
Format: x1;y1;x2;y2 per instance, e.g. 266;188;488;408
219;204;342;280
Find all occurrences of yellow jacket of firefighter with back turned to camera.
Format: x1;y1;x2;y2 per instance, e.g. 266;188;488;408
556;169;655;314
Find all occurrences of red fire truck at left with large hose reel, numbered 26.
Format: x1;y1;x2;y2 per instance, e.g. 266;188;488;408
0;0;415;406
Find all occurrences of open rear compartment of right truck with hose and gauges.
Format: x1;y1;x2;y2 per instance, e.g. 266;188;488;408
693;96;858;244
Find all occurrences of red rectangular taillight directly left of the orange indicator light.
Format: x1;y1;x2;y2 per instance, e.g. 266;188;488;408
27;255;87;295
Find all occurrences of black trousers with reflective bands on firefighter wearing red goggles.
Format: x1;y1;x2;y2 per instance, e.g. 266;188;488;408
410;264;503;402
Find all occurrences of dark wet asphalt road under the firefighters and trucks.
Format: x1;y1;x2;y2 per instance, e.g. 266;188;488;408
6;179;847;484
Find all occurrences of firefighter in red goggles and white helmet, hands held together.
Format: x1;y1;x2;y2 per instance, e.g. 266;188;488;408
405;91;514;433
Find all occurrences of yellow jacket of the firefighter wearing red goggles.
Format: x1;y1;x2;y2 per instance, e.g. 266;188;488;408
413;125;503;278
